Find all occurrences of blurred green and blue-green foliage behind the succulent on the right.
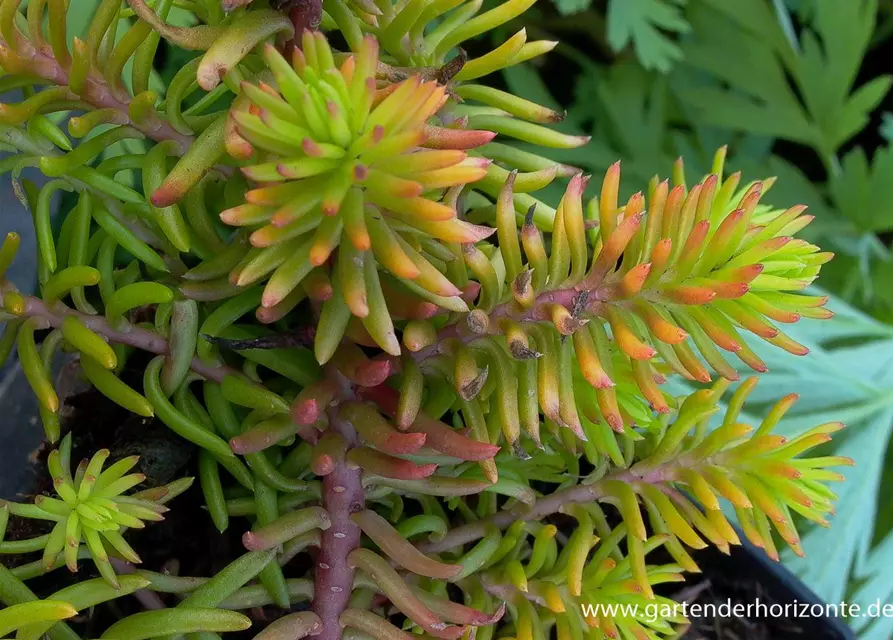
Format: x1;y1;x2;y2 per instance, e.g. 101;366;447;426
10;0;893;640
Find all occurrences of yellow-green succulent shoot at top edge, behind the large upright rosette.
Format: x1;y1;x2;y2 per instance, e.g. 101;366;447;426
324;0;589;215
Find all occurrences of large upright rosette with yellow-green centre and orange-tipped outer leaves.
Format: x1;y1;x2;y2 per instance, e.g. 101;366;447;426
220;32;494;361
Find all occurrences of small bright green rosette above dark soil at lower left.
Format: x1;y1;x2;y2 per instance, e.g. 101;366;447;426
4;435;192;588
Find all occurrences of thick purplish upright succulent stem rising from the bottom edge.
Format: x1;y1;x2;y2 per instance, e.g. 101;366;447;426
313;374;365;640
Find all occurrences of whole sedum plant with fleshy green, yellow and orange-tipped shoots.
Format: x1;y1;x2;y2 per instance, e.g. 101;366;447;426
0;0;851;640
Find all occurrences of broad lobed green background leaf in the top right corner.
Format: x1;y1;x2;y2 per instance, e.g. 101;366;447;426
679;0;891;159
